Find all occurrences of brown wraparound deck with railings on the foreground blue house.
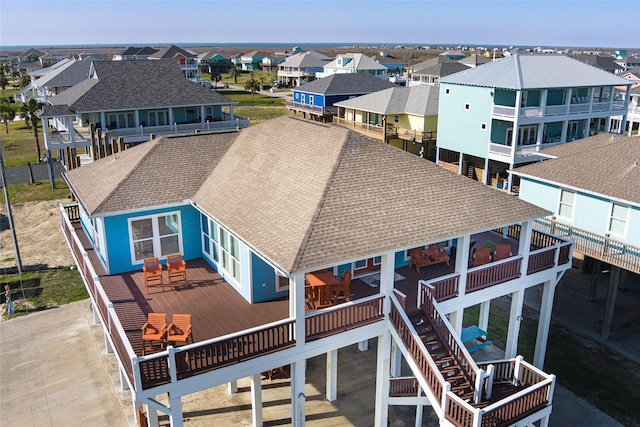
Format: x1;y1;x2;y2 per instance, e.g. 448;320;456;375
60;205;571;400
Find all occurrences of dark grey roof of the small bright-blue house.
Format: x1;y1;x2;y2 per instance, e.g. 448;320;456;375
294;73;396;96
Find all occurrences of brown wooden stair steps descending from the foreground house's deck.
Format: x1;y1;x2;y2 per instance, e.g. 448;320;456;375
417;320;474;403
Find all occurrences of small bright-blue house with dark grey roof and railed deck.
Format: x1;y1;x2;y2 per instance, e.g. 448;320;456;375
287;74;395;121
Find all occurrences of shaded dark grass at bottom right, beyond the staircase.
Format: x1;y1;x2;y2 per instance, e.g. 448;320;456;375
463;297;640;426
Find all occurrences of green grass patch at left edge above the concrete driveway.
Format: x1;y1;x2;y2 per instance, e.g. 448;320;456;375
2;268;89;318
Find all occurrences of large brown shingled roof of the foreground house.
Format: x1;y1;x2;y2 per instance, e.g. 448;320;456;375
66;116;549;273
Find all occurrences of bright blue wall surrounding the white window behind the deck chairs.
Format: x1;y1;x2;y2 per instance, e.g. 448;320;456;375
104;205;202;274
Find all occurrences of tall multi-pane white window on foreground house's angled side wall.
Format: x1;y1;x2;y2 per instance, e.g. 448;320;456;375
200;215;240;283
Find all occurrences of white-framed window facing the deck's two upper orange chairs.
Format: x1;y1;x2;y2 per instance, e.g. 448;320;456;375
129;212;182;264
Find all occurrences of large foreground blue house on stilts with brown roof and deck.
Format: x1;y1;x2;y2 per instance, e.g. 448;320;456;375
61;116;571;427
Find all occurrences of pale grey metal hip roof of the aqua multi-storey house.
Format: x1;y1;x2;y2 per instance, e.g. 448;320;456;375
440;54;631;90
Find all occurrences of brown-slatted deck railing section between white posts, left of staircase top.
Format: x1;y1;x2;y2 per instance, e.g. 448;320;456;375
305;295;384;342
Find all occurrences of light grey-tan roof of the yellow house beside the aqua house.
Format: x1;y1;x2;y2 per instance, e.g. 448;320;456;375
334;85;440;117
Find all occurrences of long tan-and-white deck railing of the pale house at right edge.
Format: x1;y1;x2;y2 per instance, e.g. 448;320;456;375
535;218;640;274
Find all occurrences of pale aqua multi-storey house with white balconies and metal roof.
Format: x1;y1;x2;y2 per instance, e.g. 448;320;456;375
438;54;631;191
